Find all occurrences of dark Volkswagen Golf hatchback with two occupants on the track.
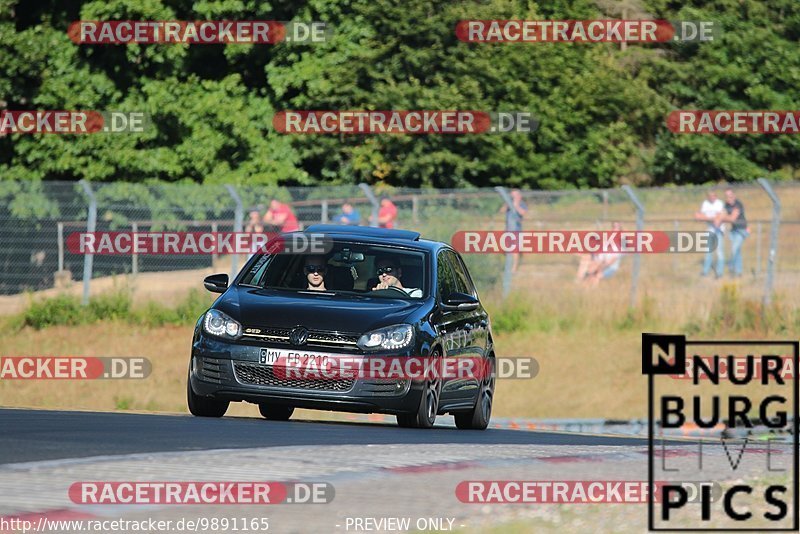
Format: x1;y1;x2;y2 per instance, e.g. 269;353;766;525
187;225;495;430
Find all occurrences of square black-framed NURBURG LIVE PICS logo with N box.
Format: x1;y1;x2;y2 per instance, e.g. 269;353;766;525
642;333;800;532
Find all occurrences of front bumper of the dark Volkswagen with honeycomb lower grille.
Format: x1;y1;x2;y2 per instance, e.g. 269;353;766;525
189;334;422;414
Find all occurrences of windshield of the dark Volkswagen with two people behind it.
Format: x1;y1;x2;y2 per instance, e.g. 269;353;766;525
239;241;428;299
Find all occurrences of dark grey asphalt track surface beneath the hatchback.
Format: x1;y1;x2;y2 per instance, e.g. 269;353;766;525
0;409;647;464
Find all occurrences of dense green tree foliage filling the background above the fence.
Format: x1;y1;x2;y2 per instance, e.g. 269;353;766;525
0;0;800;189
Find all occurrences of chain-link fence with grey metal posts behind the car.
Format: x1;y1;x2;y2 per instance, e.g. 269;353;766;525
0;181;800;310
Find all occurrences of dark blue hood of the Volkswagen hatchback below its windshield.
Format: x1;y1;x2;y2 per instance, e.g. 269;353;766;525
214;288;424;333
